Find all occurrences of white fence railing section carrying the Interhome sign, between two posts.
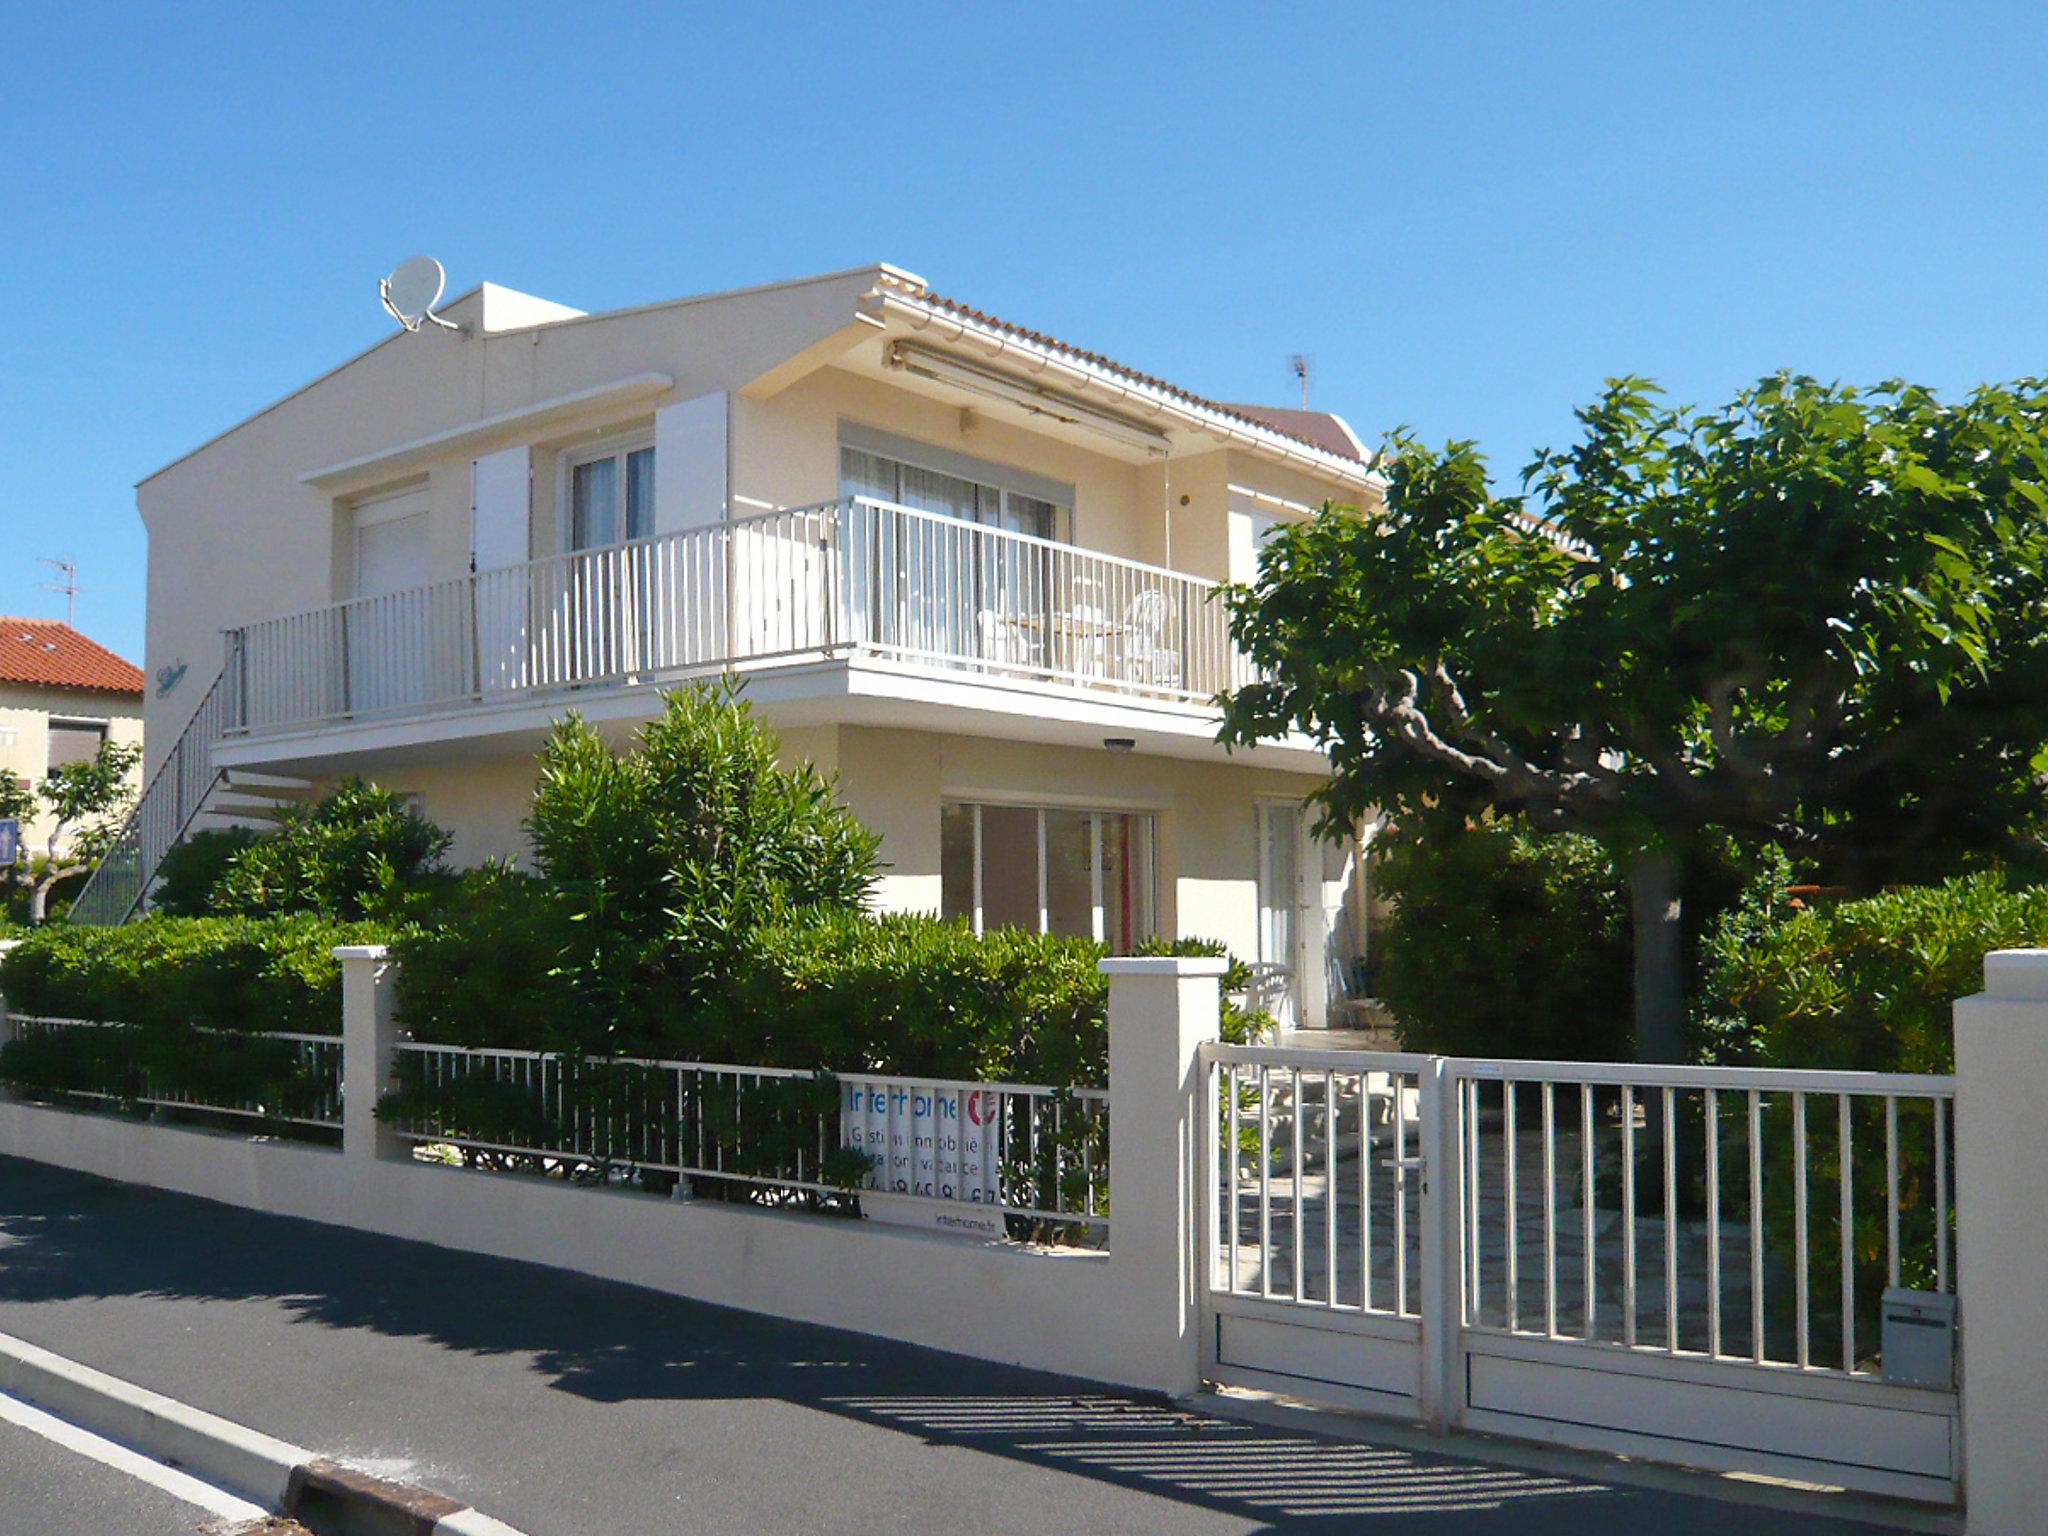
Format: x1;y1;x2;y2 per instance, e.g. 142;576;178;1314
387;1040;1108;1233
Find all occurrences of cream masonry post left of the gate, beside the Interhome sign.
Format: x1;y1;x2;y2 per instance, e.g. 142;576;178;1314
1102;956;1225;1395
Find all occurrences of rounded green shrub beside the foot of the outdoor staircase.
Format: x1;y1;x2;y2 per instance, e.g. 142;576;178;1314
213;778;451;918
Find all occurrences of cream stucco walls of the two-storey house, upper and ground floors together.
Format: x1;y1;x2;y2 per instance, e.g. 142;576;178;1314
137;268;1356;1011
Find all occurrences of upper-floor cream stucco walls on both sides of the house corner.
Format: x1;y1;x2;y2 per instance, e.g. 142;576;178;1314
137;268;1384;786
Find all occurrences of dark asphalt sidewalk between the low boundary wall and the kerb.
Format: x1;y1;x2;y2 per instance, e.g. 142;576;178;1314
0;1159;1870;1536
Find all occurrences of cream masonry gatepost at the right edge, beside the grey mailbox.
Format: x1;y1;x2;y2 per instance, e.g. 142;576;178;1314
1956;950;2048;1536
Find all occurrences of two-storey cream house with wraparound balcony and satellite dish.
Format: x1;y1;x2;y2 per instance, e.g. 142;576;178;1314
119;264;1382;1022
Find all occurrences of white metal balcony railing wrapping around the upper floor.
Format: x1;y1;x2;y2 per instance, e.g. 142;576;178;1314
225;498;1241;733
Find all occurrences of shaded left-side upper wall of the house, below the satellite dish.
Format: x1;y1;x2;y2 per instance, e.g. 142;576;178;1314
135;268;888;782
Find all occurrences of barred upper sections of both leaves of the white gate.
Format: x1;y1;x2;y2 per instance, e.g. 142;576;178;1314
1204;1044;1956;1378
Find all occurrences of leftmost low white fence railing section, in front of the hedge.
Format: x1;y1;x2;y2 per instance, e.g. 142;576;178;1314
6;1014;342;1130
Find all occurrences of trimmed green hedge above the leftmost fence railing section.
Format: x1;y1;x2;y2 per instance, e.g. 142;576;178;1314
0;915;387;1034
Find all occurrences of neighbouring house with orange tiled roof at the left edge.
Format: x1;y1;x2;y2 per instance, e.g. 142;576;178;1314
0;616;143;854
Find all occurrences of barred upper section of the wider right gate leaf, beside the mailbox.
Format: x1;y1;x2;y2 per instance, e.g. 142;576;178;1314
1448;1061;1956;1374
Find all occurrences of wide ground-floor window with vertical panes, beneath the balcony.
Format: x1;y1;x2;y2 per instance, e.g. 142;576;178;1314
940;801;1155;954
